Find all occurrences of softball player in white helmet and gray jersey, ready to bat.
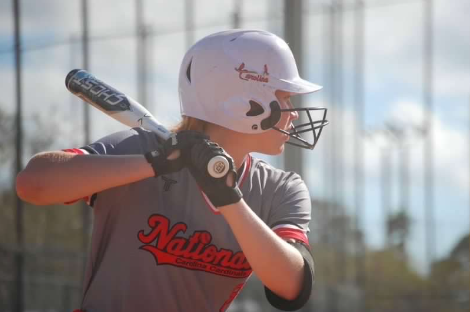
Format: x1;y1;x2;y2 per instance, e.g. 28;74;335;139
17;30;327;312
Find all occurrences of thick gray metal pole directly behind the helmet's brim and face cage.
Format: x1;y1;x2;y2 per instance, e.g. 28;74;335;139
284;0;303;175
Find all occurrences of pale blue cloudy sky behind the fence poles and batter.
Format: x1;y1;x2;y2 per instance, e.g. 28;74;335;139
0;0;470;274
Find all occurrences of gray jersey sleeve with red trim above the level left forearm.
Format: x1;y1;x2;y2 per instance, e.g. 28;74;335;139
59;128;158;206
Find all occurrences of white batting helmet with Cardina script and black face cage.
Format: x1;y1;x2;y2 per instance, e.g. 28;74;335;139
179;30;328;149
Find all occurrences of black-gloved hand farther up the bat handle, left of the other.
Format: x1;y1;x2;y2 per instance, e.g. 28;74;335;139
145;130;209;177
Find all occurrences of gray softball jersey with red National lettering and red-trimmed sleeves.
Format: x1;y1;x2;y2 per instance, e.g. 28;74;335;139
68;128;310;312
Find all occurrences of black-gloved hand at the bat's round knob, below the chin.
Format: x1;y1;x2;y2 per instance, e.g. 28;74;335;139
188;139;243;207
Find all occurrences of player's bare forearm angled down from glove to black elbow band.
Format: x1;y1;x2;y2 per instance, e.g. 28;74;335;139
220;200;304;300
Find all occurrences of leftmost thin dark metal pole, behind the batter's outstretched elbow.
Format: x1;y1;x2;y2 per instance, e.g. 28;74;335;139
13;0;24;312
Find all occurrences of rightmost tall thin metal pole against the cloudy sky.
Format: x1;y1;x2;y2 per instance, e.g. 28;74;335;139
423;0;436;269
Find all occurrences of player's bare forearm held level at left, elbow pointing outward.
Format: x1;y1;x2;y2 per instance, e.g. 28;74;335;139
16;152;153;205
